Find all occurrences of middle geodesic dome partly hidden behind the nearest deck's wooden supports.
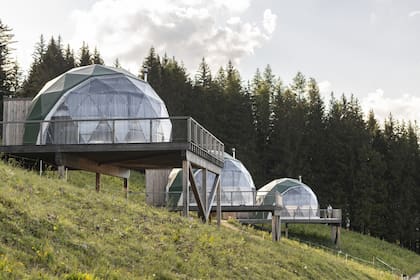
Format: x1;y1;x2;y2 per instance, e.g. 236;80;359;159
166;153;255;205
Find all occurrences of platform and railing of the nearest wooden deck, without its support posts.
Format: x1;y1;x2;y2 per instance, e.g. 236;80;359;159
0;117;224;172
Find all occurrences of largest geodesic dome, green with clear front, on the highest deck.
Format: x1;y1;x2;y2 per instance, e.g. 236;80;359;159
24;65;172;144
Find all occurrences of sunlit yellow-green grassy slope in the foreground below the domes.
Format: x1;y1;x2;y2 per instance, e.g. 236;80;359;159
0;163;412;279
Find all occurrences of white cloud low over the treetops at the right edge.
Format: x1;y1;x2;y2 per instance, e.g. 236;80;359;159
361;88;420;121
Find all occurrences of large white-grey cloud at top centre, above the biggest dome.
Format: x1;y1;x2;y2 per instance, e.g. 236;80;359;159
71;0;276;72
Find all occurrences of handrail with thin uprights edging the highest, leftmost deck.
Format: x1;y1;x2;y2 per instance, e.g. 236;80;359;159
0;116;224;162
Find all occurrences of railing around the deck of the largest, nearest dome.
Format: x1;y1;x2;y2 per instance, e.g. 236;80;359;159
1;117;224;162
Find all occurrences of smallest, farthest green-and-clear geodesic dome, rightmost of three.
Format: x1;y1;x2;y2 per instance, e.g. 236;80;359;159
256;178;319;217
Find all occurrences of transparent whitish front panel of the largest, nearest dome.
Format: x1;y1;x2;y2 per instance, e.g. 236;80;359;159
38;68;172;144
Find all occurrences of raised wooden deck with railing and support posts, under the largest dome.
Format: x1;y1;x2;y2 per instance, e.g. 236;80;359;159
0;117;224;225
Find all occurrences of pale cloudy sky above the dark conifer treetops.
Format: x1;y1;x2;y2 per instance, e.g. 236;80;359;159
0;0;420;121
